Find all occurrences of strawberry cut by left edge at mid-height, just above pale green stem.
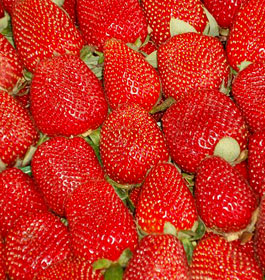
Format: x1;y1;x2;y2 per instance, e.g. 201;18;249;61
0;91;38;165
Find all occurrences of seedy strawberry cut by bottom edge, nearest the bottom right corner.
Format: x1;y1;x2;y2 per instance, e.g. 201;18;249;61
191;235;263;280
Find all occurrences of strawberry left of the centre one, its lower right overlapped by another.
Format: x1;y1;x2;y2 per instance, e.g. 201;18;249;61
31;137;104;215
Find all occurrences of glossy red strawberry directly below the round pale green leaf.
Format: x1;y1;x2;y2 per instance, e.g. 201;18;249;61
195;156;257;232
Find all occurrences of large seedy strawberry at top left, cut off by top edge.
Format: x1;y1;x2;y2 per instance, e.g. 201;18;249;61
12;0;83;72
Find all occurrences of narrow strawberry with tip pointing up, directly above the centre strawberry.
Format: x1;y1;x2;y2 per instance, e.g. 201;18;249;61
104;39;160;111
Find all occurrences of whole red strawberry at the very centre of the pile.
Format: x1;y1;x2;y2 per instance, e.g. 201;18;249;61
100;104;169;184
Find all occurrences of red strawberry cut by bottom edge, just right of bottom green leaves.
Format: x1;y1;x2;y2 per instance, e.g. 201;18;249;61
123;235;191;280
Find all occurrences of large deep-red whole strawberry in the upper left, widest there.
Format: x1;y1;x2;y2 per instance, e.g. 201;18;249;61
30;54;108;136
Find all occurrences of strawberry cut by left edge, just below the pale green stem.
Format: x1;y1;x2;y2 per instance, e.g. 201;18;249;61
0;168;47;237
